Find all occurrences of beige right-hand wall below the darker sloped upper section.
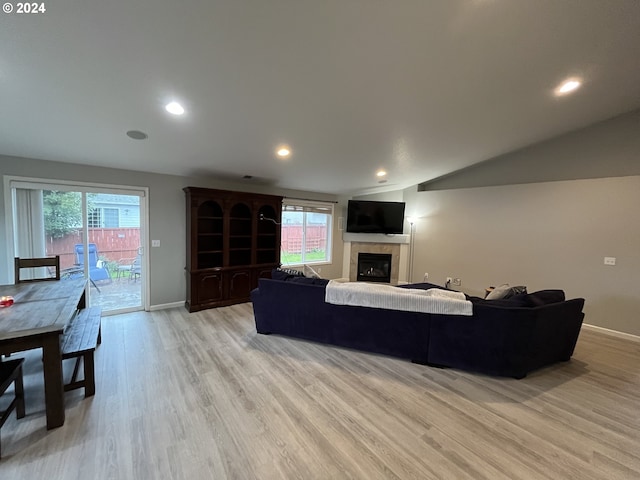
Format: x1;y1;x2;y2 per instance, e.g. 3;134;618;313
404;176;640;335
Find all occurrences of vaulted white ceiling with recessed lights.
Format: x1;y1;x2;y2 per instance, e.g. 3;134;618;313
0;0;640;194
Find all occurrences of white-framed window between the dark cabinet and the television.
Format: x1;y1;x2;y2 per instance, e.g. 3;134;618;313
280;199;333;265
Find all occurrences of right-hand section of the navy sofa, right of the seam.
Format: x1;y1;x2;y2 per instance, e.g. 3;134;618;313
428;298;584;378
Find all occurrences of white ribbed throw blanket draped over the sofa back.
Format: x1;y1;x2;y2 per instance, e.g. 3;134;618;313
325;280;473;316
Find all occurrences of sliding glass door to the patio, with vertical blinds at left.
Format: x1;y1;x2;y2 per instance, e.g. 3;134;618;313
11;181;147;313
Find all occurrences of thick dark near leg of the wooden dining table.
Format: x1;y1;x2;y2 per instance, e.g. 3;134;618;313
42;332;64;430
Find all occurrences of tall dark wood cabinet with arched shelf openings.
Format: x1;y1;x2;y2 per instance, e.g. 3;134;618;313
184;187;282;312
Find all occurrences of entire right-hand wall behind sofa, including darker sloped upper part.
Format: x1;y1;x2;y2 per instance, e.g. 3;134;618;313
404;110;640;335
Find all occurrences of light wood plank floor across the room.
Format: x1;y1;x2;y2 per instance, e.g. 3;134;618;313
0;304;640;480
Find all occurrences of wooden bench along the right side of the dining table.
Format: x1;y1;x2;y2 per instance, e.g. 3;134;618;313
61;307;102;397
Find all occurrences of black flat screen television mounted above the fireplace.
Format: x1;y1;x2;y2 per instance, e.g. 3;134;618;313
347;200;405;234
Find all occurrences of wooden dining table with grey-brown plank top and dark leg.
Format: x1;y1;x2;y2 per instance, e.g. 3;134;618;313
0;278;87;430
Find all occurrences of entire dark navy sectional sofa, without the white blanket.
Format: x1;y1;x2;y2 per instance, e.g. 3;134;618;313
251;277;584;378
